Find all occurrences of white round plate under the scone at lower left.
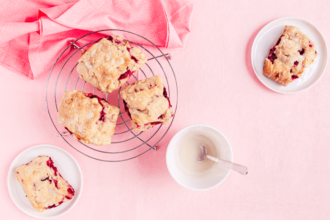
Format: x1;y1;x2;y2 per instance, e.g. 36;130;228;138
7;144;83;219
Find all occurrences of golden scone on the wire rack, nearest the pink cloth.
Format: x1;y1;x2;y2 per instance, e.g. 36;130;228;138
77;36;147;93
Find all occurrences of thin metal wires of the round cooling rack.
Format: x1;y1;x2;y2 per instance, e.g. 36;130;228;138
46;29;178;162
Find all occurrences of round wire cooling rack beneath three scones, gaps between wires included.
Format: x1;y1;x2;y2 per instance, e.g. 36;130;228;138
46;29;178;162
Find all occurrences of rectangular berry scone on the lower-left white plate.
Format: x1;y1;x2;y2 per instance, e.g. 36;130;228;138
15;156;75;212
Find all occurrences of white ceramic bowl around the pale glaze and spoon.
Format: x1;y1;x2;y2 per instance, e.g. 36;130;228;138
166;125;233;191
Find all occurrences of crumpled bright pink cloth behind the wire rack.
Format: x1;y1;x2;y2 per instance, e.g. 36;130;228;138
0;0;193;79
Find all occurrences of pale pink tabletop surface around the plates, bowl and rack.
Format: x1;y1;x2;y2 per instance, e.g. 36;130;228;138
0;0;330;220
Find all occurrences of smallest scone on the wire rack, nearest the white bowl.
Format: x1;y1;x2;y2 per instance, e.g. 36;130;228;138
120;76;174;131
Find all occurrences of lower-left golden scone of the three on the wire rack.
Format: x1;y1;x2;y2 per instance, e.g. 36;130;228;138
58;90;119;146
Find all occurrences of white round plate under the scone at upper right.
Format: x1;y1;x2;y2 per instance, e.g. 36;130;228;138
251;17;328;94
